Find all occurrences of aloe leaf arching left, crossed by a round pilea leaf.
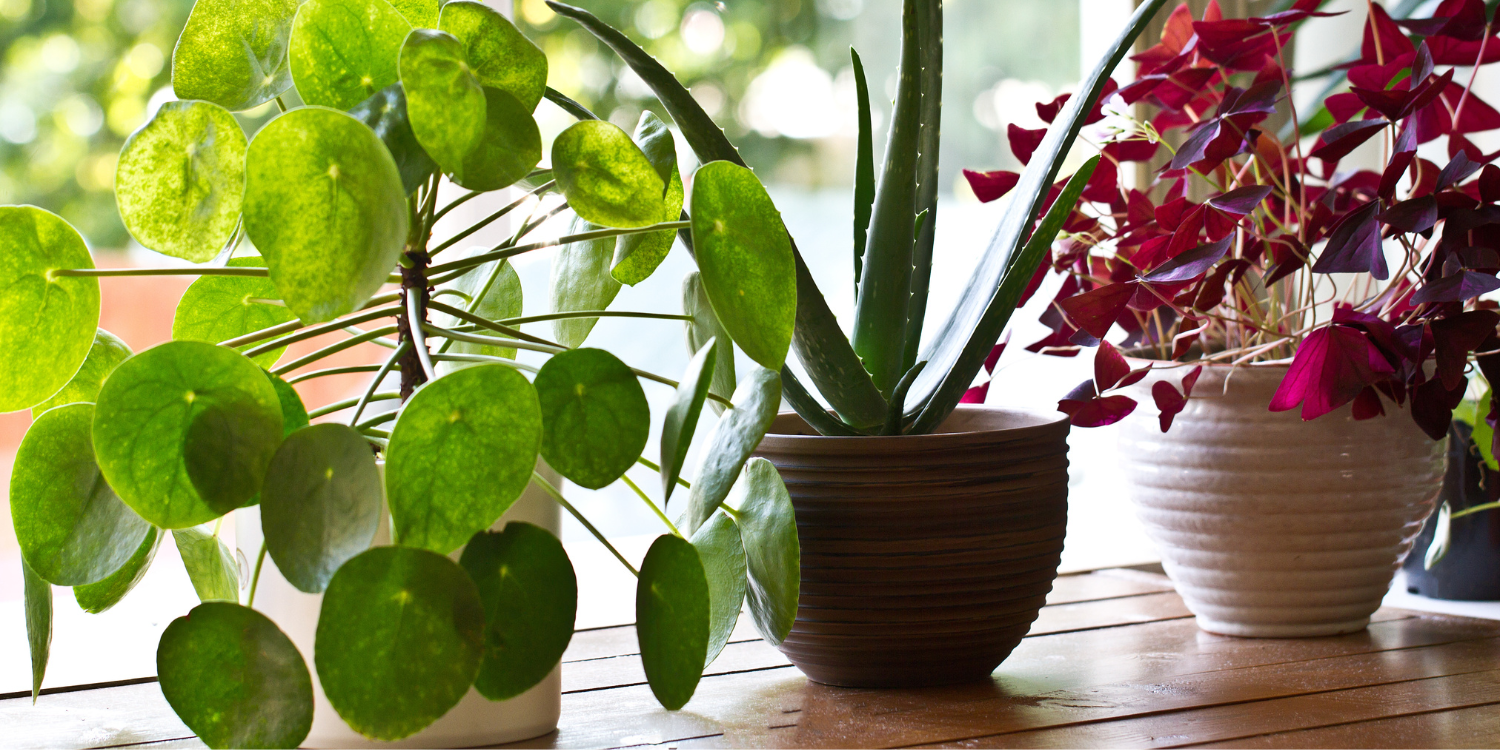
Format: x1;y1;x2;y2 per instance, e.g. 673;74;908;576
548;0;887;432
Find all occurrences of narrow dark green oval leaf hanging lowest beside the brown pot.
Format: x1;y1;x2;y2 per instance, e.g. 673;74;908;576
636;534;711;711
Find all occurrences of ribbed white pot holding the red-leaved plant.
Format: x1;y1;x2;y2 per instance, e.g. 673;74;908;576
1119;362;1446;638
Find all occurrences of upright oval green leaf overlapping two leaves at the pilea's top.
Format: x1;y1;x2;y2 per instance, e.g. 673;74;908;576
401;29;488;174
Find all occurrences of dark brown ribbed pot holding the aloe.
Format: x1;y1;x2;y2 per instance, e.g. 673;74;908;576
756;405;1068;687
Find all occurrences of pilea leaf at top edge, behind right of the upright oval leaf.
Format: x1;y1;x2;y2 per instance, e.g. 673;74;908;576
438;0;548;113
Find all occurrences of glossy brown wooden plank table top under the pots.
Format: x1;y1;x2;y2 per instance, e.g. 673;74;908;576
0;570;1500;749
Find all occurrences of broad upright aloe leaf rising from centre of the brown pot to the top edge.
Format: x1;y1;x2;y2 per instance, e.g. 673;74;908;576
851;0;923;399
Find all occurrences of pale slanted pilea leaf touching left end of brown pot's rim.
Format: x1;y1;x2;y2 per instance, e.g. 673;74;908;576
686;368;782;534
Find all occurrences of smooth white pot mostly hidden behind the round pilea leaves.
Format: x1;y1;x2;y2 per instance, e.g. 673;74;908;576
234;461;563;747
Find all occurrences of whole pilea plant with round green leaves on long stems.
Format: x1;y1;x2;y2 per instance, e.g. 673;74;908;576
0;0;800;747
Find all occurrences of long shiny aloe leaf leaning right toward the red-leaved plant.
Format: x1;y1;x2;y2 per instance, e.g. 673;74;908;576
911;0;1167;432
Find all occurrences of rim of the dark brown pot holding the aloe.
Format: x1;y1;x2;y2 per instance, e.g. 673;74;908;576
761;404;1070;450
